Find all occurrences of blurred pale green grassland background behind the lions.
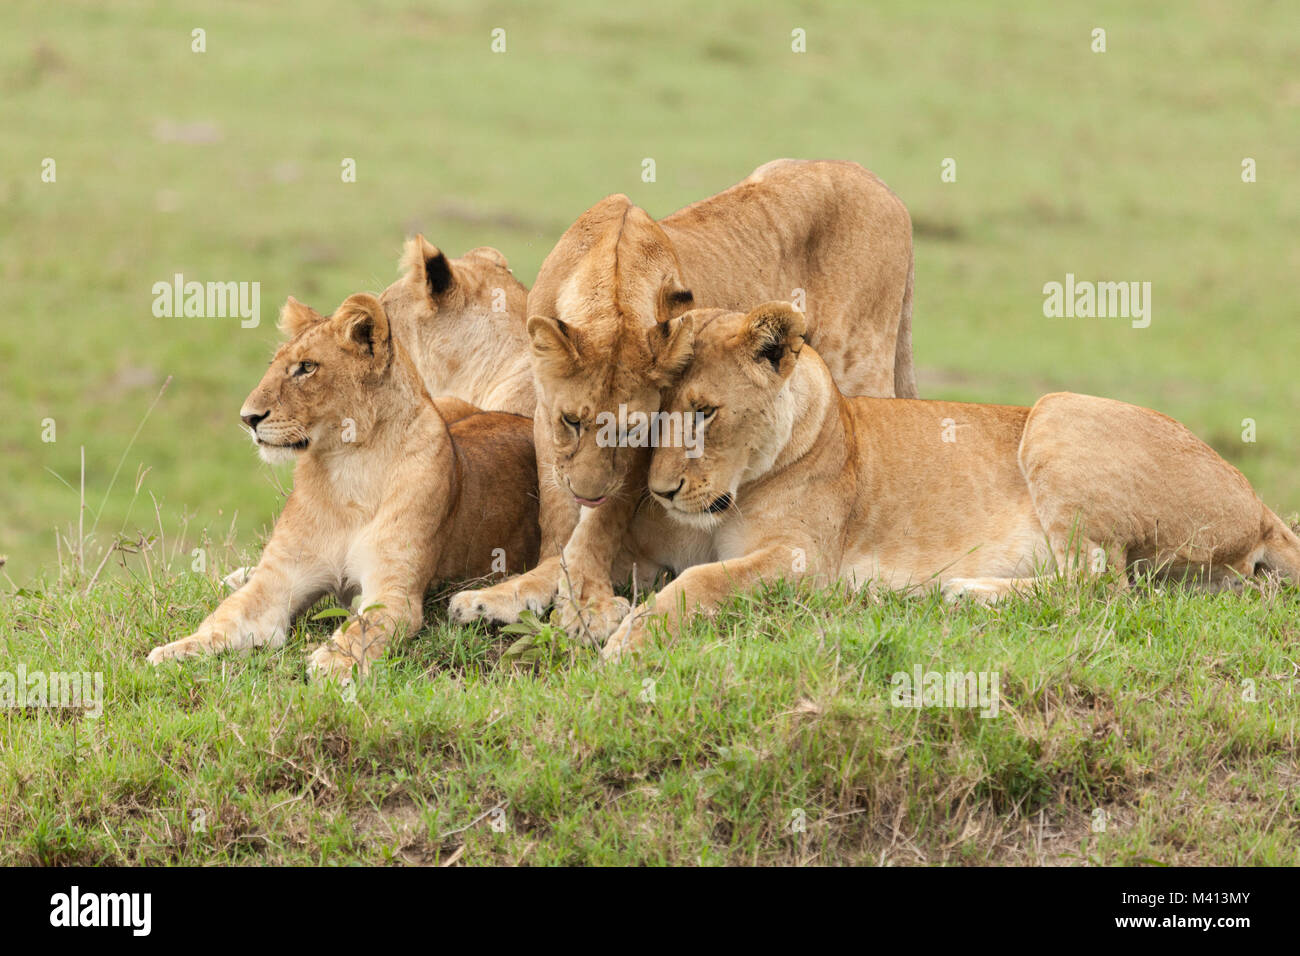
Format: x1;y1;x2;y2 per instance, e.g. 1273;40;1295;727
0;0;1300;583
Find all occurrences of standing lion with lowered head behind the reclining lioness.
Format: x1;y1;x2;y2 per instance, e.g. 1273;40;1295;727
451;160;917;641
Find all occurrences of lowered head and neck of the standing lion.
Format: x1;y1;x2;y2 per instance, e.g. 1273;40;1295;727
528;196;692;506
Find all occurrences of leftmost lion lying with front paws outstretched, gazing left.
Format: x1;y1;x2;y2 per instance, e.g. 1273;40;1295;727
148;295;538;680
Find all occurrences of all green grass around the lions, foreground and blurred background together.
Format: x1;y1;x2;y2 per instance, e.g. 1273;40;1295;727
0;0;1300;864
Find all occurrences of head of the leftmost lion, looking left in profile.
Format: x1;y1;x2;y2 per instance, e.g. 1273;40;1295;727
239;295;395;464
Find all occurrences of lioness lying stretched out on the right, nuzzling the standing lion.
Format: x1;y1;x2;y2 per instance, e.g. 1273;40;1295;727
603;302;1300;657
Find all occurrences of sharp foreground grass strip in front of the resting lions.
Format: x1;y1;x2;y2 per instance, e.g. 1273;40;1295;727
0;558;1300;865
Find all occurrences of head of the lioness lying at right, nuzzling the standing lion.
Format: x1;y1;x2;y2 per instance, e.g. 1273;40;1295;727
649;302;807;529
